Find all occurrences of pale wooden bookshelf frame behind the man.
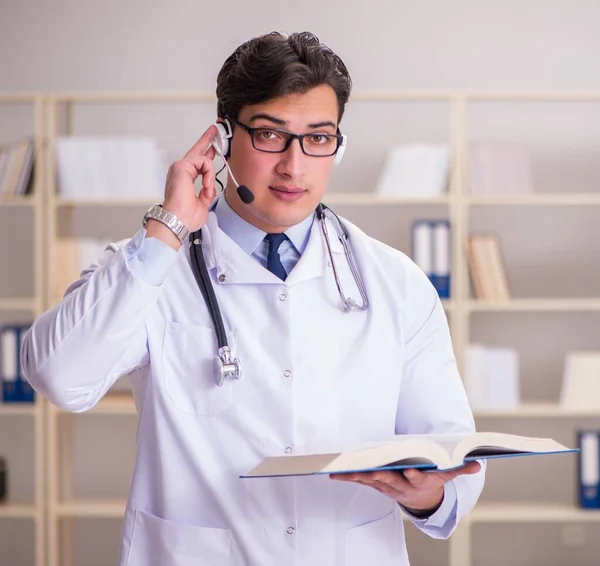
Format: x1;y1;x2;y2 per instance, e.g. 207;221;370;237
0;91;600;566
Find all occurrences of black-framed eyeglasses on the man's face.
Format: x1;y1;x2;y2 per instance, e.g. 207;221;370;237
229;117;343;157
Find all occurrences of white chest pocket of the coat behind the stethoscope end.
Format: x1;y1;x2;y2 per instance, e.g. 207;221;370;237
163;322;237;416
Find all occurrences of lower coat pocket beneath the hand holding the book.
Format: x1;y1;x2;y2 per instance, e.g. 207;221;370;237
344;509;407;566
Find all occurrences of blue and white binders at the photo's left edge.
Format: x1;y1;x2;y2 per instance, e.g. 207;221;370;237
0;324;35;403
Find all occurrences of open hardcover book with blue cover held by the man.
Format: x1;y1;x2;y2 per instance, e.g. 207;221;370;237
240;432;579;478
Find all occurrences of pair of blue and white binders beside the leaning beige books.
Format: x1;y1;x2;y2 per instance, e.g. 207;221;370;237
412;220;450;299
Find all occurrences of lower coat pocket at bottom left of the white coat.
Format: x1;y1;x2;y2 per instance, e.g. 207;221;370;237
127;509;231;566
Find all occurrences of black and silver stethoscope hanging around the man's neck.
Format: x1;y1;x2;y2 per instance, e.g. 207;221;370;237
190;204;369;386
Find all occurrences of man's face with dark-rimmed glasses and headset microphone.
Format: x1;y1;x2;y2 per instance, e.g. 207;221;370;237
226;85;338;232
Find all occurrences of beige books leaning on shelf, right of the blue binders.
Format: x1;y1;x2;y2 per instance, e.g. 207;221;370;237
467;234;510;301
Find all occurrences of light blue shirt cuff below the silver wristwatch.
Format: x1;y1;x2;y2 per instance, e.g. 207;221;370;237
123;228;185;287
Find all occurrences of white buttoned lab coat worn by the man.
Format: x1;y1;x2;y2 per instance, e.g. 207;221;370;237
22;213;485;566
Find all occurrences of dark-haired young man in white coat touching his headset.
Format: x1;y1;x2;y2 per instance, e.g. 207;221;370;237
23;33;484;566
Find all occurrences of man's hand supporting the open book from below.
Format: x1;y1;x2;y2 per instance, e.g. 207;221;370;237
329;462;481;516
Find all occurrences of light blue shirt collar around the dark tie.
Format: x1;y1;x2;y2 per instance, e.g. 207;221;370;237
214;193;315;255
